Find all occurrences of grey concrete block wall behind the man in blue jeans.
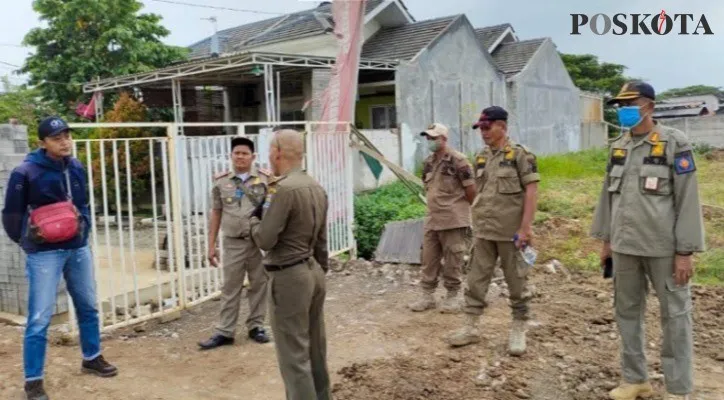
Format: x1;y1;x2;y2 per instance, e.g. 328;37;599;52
0;125;68;315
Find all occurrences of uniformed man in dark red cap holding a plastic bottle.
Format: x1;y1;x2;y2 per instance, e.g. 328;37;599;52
447;106;540;356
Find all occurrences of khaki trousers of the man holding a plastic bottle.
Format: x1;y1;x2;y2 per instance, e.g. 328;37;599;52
464;238;530;320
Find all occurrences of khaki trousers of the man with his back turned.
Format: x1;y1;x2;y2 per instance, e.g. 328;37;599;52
269;258;332;400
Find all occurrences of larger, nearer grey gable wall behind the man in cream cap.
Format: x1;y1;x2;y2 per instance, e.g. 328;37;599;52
395;16;504;165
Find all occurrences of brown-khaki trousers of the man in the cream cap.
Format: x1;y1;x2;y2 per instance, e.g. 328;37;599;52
420;228;468;291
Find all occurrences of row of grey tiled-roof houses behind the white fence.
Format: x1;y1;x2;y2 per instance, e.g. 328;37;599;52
84;0;580;164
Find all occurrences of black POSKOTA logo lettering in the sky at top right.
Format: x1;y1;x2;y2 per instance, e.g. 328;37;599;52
571;10;714;36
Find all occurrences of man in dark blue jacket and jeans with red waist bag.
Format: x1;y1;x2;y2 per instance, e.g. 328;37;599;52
2;117;118;400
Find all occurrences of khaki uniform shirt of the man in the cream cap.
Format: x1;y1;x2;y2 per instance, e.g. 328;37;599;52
422;148;475;231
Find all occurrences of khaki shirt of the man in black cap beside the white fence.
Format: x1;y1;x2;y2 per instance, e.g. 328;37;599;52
211;169;268;238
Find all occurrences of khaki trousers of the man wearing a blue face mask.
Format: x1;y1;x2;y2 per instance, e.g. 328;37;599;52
612;252;694;395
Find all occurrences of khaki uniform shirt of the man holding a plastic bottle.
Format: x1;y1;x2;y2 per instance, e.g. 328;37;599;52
473;139;540;241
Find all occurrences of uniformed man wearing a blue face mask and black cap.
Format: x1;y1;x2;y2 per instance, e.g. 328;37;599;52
591;81;704;400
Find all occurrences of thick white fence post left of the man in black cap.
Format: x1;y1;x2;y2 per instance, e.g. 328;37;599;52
166;124;186;309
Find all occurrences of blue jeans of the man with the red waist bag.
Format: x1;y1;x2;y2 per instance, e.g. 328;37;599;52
23;246;101;381
